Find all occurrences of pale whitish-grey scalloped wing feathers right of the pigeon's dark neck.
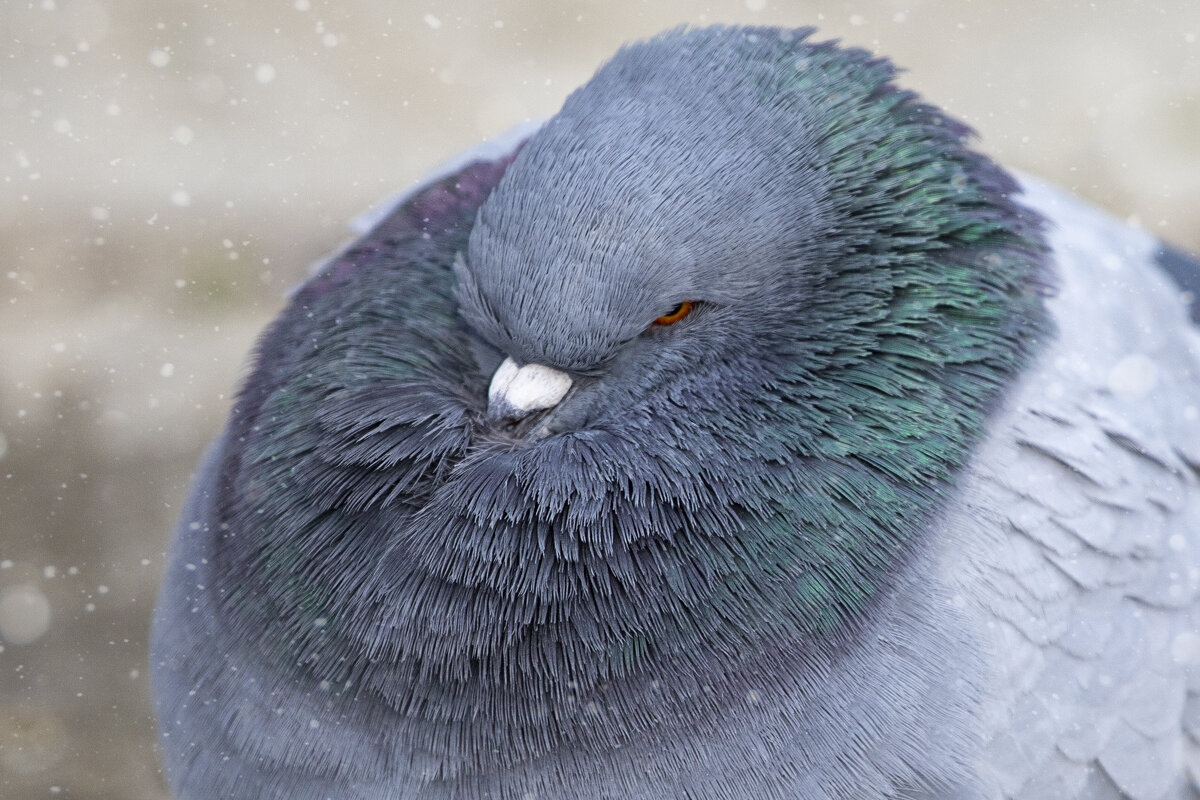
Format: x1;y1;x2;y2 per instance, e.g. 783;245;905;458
942;179;1200;800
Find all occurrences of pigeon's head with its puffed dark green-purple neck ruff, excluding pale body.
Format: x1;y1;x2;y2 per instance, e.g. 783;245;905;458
214;28;1046;780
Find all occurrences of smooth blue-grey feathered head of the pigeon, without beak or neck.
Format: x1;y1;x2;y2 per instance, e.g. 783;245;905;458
458;34;832;434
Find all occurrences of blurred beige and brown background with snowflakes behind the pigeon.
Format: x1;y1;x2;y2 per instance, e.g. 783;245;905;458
0;0;1200;800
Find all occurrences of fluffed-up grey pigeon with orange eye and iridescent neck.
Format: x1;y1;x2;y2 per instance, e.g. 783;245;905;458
150;26;1200;800
